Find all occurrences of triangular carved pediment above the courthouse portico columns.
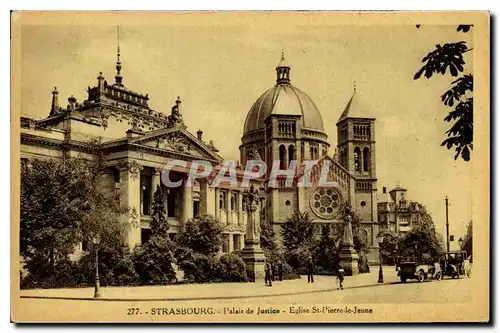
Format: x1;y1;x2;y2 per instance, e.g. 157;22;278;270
133;129;221;160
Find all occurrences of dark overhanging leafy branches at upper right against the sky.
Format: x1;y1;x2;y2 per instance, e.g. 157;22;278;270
413;25;474;161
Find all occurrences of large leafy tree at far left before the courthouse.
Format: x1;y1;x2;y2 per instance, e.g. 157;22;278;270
20;159;81;280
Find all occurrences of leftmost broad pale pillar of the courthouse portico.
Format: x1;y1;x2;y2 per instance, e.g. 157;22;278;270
117;161;142;248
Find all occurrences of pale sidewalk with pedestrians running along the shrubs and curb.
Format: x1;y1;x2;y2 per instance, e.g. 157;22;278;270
21;266;399;301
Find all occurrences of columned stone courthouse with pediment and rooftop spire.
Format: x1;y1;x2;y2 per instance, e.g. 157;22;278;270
21;45;261;252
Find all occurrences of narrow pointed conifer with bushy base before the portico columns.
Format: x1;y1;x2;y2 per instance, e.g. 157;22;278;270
134;185;176;284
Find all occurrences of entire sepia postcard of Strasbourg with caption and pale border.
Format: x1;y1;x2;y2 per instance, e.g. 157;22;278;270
11;11;490;323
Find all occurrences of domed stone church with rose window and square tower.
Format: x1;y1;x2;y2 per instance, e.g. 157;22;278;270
240;55;378;262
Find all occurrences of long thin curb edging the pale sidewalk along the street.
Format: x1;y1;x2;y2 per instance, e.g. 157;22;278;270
20;282;400;302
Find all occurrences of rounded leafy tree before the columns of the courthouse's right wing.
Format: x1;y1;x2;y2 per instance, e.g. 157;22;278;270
178;215;222;255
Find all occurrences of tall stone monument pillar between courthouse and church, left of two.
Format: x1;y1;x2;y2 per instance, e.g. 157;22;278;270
241;188;265;282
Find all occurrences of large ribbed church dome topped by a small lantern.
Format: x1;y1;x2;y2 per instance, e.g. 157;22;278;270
243;56;324;135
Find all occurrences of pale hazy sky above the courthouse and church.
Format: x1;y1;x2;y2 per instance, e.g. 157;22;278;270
17;15;474;244
